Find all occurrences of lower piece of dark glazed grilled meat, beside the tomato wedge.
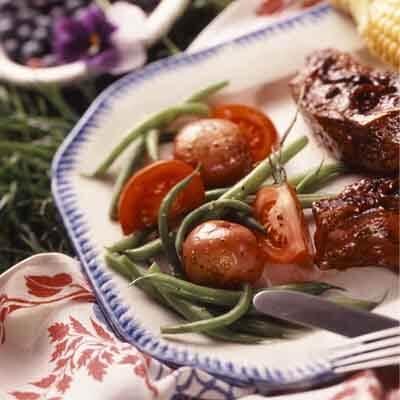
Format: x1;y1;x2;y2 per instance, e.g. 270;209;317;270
313;178;400;269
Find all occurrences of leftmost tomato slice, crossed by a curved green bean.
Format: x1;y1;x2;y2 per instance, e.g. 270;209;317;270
118;160;205;235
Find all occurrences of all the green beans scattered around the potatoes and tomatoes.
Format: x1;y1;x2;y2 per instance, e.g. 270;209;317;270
96;81;366;344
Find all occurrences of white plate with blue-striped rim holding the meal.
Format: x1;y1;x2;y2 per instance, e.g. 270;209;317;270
53;5;398;387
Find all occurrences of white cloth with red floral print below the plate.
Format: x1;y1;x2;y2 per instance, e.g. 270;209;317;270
0;254;400;400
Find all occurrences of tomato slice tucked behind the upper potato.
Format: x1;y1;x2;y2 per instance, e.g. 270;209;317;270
213;104;278;163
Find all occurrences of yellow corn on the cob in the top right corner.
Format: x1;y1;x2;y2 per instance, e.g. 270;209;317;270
331;0;400;71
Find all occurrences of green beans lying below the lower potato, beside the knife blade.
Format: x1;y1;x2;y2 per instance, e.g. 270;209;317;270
105;252;377;344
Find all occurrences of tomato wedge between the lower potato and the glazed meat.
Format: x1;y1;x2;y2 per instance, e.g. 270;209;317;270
254;183;312;264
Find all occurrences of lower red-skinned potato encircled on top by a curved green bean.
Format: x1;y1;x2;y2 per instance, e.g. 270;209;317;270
183;220;264;289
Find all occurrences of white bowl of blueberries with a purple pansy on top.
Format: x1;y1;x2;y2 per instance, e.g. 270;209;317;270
0;0;190;85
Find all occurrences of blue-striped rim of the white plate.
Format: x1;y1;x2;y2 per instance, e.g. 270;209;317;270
52;4;337;392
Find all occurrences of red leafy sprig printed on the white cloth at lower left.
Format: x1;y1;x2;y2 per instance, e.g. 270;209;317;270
10;317;158;400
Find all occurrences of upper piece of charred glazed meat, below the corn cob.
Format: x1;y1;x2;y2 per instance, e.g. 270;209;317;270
290;49;400;176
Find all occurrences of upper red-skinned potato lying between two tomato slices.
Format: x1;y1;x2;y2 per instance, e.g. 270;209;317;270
174;118;252;187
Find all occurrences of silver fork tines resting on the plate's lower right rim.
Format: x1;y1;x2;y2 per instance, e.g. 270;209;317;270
326;325;400;374
